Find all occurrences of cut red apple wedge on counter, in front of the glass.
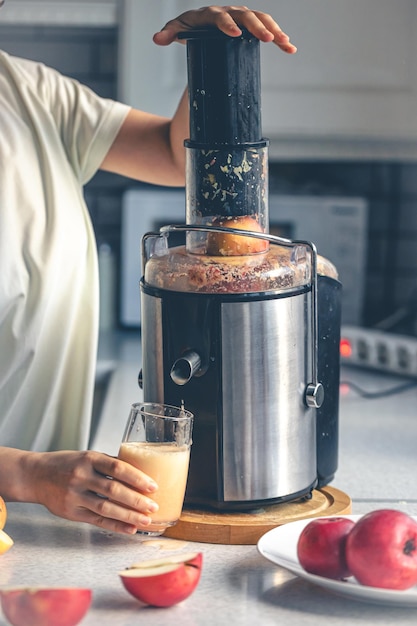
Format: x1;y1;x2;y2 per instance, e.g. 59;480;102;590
119;552;203;607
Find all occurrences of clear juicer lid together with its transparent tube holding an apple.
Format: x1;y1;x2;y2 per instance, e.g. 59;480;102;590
143;140;336;294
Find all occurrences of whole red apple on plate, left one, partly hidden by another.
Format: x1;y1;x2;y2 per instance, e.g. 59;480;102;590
297;517;355;580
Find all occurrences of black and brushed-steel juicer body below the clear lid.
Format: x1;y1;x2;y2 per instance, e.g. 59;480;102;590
141;279;340;510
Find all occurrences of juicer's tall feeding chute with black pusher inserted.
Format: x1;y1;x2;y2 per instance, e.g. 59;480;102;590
180;29;268;255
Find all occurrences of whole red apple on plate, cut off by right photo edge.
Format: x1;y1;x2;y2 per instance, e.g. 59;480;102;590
346;509;417;589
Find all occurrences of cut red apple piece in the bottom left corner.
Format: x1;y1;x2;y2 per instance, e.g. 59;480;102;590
0;587;92;626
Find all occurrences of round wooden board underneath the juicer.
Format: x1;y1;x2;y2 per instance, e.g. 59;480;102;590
164;486;352;545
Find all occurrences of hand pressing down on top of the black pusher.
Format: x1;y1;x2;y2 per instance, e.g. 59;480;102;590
153;6;297;54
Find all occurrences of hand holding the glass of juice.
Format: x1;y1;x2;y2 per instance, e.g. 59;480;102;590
0;448;158;534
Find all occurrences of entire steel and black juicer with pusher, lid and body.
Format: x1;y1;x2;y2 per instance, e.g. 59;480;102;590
136;30;341;511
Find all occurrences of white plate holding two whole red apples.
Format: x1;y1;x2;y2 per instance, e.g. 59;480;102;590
258;515;417;607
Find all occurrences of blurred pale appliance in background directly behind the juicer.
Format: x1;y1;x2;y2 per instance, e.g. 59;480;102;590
120;187;368;328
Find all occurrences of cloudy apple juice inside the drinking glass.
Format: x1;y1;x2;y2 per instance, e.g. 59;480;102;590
119;441;190;532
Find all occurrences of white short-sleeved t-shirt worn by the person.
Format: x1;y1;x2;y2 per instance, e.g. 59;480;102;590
0;52;129;450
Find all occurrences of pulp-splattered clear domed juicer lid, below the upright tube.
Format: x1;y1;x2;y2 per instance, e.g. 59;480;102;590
143;225;336;294
